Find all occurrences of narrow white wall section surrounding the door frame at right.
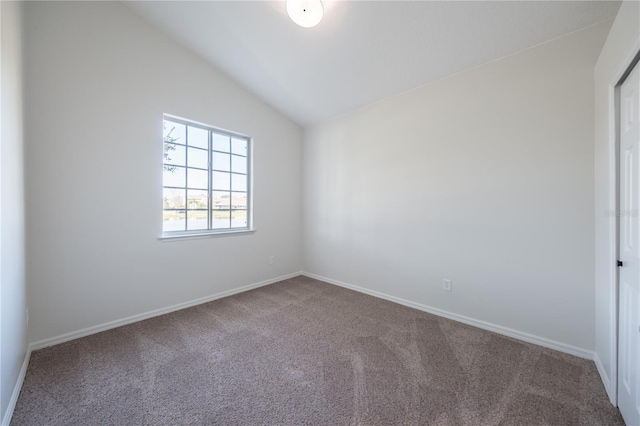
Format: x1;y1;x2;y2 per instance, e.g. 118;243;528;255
595;1;640;398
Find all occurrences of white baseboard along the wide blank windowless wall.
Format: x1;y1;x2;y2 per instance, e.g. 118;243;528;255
302;272;594;360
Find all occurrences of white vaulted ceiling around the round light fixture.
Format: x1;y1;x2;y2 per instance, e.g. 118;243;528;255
125;0;620;126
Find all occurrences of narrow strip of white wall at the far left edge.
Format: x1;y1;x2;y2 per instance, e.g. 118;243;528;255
0;1;27;424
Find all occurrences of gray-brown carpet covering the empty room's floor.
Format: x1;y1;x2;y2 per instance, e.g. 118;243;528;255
11;277;623;426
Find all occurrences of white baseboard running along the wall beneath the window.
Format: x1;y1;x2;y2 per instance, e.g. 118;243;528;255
29;272;302;351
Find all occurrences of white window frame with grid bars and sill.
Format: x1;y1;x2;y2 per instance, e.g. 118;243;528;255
159;114;255;240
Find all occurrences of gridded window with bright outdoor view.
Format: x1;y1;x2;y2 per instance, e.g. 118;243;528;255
162;116;251;236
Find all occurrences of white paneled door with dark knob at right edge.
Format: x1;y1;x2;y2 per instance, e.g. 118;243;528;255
618;60;640;426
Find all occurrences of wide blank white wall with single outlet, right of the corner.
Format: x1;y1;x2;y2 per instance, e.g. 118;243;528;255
303;22;611;354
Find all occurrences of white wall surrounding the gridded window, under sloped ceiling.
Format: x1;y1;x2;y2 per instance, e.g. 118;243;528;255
25;2;302;342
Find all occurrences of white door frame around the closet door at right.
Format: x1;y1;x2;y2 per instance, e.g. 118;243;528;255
605;35;640;407
